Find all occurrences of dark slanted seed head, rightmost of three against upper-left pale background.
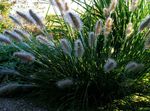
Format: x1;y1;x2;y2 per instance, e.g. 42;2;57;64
29;9;44;29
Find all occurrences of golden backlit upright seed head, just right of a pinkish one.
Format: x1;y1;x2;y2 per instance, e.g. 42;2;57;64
104;17;113;36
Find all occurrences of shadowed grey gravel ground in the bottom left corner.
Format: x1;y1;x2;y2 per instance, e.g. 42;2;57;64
0;98;48;111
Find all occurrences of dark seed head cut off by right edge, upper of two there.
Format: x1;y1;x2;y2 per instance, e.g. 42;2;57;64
139;15;150;31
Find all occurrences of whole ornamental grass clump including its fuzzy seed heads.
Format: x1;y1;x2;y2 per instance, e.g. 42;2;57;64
0;0;150;111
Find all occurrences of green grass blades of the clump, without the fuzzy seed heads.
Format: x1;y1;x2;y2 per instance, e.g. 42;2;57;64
1;0;150;110
